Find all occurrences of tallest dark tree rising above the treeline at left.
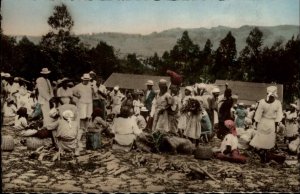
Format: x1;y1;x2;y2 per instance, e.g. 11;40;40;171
40;4;82;76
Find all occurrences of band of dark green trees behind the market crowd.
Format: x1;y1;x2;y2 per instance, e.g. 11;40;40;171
0;4;300;103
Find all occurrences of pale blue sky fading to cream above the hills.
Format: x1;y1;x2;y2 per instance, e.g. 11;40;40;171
1;0;300;36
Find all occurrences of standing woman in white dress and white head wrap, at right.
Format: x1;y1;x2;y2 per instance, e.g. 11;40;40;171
250;86;283;162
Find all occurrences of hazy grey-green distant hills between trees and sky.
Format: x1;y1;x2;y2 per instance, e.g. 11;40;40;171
17;25;300;57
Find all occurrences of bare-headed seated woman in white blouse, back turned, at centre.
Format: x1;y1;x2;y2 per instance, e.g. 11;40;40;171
111;106;142;150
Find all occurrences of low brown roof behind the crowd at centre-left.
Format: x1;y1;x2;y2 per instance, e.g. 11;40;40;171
104;73;170;90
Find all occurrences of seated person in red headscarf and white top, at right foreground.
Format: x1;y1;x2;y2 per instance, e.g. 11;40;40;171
215;120;247;164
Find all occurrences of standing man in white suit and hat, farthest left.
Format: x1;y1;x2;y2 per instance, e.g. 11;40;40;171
36;68;53;126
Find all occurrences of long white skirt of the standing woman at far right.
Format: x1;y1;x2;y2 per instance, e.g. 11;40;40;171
250;118;276;149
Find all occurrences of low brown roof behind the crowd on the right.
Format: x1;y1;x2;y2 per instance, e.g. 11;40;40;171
215;80;283;105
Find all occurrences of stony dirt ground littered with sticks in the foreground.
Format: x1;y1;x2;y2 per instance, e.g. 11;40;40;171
2;127;300;192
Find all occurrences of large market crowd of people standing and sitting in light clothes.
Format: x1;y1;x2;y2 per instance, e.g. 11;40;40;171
1;68;300;163
